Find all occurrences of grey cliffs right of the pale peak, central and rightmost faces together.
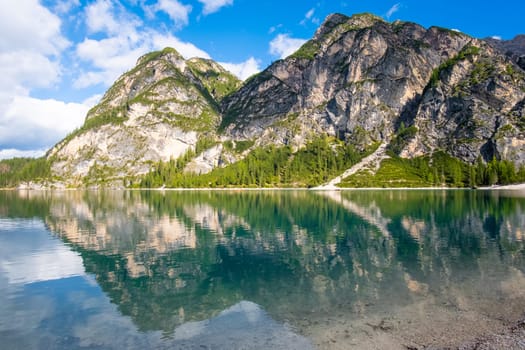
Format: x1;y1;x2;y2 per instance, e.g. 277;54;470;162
223;14;525;164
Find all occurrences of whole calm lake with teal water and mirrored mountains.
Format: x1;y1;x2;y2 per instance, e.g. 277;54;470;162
0;190;525;349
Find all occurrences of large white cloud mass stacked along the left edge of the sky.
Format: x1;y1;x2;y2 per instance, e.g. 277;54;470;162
0;0;87;158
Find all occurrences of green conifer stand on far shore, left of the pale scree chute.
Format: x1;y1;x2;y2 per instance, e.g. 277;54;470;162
140;136;370;188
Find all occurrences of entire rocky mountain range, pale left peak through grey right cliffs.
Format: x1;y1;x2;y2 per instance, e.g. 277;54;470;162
36;14;525;185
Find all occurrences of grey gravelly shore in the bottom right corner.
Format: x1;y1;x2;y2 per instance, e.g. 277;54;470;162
302;301;525;350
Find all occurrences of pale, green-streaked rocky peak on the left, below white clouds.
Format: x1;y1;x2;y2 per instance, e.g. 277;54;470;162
48;49;240;182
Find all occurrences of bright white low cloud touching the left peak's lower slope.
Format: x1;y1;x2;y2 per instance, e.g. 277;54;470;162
0;96;88;150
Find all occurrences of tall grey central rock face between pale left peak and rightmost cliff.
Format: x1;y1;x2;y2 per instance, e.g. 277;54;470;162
223;14;472;145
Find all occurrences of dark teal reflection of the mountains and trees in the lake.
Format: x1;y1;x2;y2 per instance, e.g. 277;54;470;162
0;191;525;348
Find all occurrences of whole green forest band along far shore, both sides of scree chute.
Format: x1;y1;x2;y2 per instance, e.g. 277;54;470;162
135;136;525;188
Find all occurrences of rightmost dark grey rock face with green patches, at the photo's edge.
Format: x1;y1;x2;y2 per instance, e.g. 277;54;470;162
410;41;525;164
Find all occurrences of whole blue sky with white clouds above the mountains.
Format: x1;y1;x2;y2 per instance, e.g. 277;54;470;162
0;0;525;159
